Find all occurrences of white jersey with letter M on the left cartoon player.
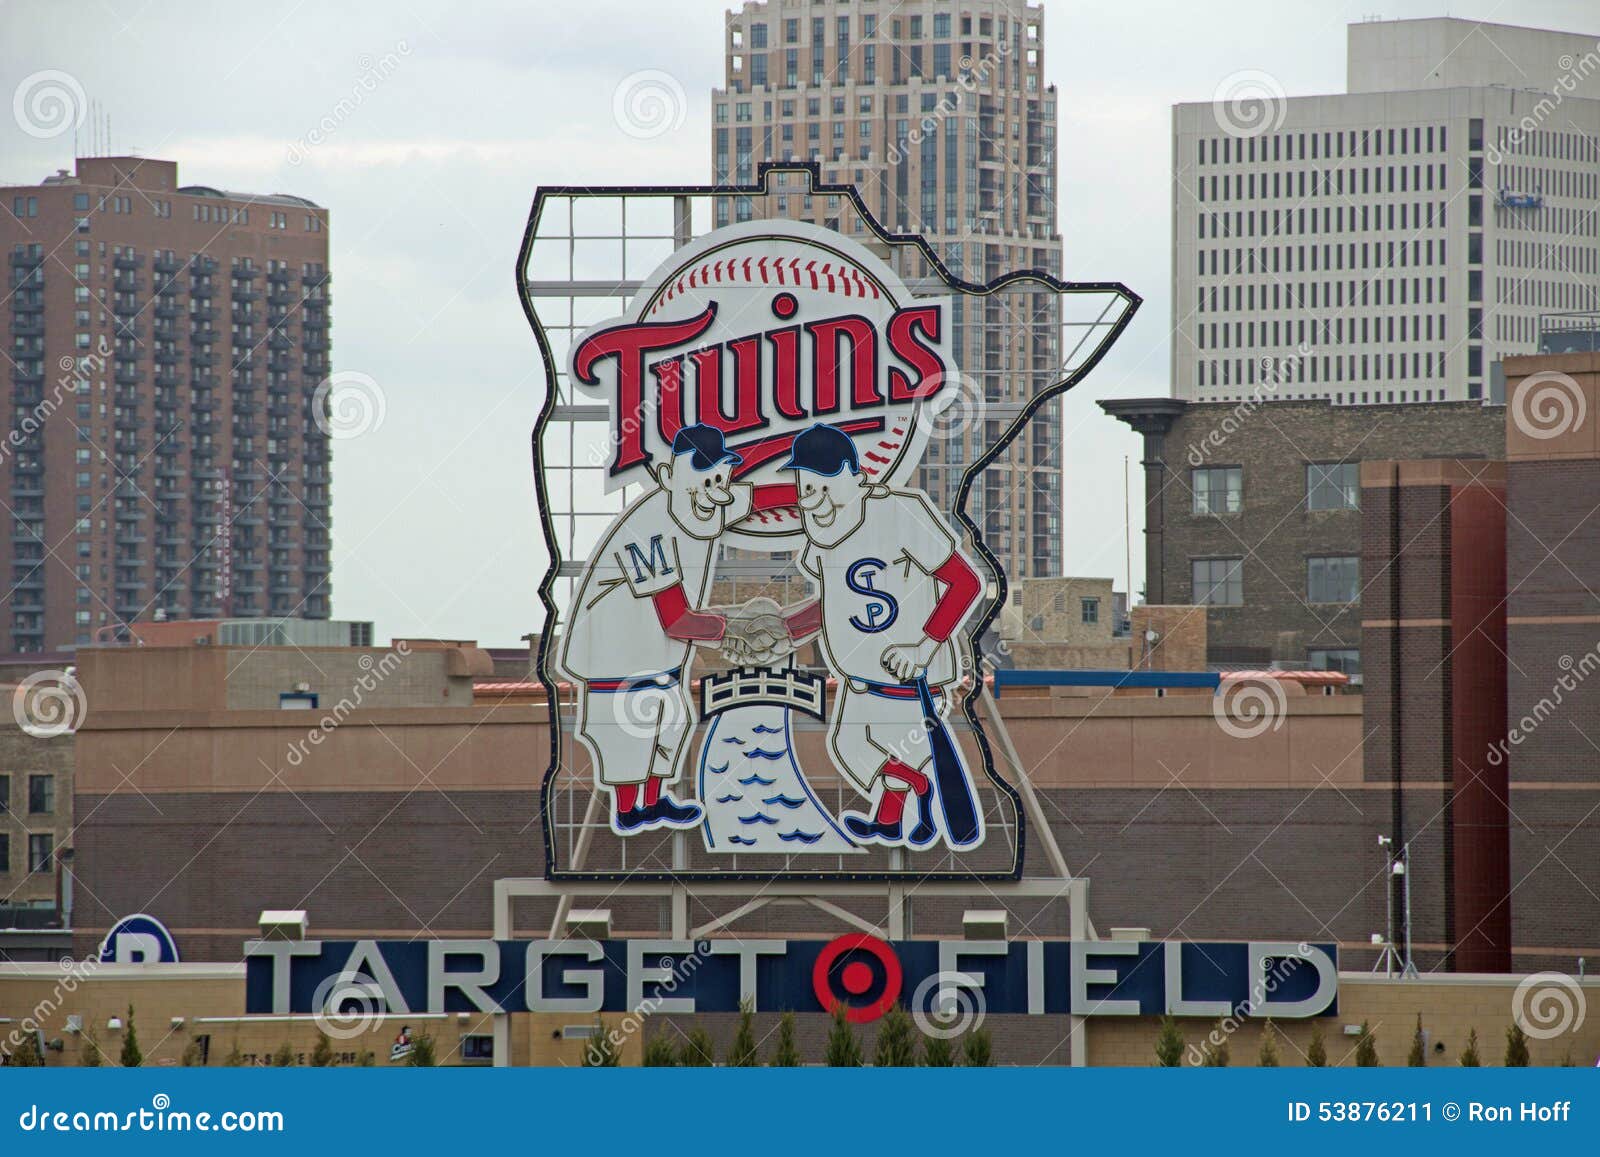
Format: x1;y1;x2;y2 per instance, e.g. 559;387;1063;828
562;490;717;680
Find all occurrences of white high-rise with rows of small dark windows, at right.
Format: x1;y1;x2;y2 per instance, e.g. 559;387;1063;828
1171;19;1600;405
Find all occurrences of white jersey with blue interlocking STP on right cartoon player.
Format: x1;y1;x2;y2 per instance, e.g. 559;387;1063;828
800;490;976;685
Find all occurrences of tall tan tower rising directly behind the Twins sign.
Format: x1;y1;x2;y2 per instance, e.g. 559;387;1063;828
712;0;1062;578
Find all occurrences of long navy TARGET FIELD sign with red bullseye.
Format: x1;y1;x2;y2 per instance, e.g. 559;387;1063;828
245;933;1339;1021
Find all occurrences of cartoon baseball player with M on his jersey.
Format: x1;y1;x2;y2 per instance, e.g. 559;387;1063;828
562;424;794;835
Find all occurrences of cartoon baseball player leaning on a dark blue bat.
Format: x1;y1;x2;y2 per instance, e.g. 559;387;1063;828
786;422;982;848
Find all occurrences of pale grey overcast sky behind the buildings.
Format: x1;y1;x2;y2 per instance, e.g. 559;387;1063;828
0;0;1600;645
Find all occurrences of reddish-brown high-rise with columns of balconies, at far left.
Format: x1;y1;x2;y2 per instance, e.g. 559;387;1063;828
0;157;330;651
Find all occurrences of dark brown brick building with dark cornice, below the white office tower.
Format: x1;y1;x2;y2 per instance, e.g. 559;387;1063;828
1101;395;1506;675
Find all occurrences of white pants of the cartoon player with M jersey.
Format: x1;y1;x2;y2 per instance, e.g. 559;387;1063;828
578;680;696;787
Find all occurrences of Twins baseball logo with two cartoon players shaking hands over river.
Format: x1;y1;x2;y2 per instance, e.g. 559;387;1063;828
525;172;1131;879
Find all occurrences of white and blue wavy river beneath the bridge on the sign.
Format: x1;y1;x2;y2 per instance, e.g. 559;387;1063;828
699;704;856;856
